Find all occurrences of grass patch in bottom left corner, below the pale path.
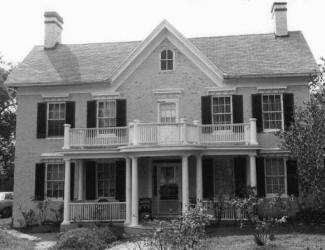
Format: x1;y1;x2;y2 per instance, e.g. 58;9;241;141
0;230;35;250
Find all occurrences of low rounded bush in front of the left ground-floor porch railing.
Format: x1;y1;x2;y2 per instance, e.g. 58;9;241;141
54;227;117;250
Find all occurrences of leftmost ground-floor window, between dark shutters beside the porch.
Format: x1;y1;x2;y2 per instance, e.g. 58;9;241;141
46;164;64;199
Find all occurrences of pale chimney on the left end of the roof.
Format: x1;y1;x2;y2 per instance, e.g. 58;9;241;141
44;11;63;49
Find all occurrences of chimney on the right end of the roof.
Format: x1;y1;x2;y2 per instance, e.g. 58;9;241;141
271;2;288;36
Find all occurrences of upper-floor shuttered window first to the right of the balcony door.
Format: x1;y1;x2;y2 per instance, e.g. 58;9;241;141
212;96;232;124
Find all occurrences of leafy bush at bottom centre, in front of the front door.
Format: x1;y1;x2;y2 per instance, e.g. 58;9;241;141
147;204;209;250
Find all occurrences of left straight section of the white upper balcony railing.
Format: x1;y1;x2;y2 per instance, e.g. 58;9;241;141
69;127;129;147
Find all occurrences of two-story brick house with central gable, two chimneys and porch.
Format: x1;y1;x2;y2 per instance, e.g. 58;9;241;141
7;3;317;229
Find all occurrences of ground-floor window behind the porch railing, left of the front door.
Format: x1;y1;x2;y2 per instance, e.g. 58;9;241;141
97;163;115;197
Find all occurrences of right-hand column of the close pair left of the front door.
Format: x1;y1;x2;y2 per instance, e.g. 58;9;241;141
130;156;139;227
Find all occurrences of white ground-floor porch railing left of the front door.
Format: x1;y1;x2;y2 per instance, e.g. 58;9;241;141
69;202;126;222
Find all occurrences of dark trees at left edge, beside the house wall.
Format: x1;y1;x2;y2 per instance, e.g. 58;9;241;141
0;55;17;189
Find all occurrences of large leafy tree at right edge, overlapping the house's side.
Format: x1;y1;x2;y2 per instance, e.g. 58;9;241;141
280;59;325;210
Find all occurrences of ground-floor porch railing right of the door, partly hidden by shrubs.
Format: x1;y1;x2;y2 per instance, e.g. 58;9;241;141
202;201;248;221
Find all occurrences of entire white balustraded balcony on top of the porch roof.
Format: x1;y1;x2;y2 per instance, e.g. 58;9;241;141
63;118;257;149
